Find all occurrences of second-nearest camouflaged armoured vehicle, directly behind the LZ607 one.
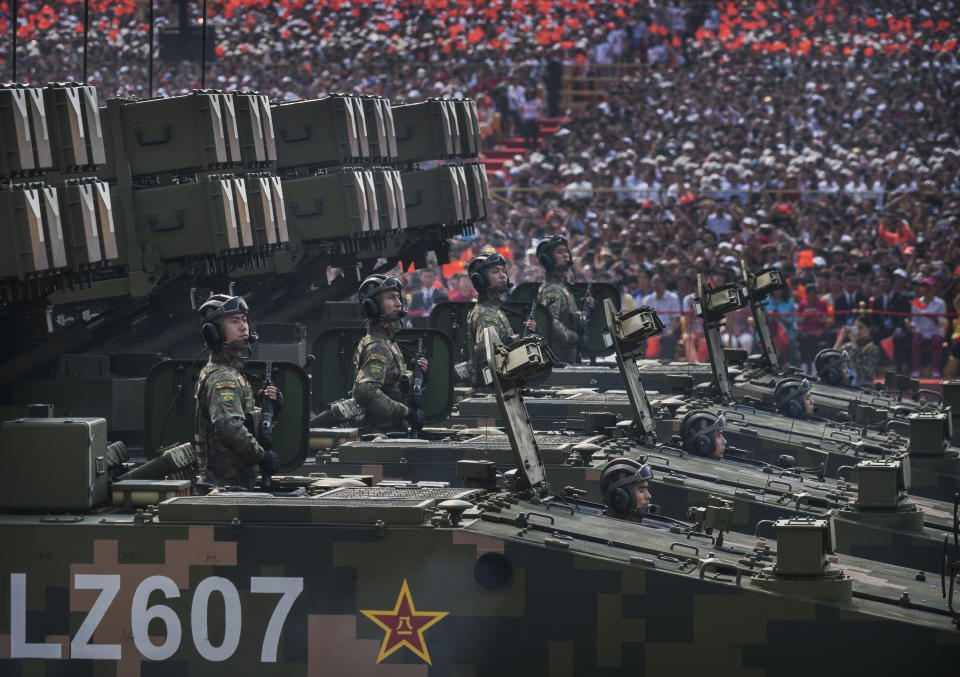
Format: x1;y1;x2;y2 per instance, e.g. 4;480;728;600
305;314;956;571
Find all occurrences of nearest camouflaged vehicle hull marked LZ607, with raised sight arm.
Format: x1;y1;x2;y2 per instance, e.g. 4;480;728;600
0;322;960;675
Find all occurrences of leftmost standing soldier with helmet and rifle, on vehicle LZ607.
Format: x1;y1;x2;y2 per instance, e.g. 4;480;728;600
195;294;283;489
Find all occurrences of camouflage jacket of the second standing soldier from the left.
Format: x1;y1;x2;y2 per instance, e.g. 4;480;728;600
353;325;409;431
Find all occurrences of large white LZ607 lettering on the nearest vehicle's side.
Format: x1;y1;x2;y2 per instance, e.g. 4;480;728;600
10;573;303;663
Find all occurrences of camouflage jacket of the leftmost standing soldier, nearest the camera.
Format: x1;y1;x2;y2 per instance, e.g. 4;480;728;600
194;352;263;489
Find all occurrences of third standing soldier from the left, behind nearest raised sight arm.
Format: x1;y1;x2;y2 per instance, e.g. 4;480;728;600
456;253;537;386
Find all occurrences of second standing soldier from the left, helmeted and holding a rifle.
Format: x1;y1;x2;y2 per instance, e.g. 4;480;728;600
353;275;430;432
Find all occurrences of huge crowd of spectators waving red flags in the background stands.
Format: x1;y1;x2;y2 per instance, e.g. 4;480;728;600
7;0;960;376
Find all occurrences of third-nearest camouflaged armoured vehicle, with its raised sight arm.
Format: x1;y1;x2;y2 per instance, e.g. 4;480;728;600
449;277;960;502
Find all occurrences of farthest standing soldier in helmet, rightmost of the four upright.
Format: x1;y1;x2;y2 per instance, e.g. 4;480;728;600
537;235;593;362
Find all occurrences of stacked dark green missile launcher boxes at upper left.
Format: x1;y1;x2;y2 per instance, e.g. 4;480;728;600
0;84;489;452
